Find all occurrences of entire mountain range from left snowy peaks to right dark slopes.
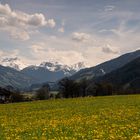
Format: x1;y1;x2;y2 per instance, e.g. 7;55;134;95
0;50;140;89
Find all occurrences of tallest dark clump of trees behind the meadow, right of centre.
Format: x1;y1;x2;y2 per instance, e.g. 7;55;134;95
59;78;113;98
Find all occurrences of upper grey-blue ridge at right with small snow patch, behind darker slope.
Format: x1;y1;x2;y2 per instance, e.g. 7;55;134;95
71;50;140;80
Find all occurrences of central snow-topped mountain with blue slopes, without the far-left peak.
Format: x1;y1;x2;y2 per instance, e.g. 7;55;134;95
21;61;85;82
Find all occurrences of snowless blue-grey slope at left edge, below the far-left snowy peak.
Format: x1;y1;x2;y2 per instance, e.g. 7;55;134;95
0;65;36;89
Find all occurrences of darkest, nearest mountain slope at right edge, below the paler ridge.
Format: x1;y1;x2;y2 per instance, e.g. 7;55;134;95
95;57;140;89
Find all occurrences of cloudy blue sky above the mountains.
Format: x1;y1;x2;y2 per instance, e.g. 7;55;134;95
0;0;140;66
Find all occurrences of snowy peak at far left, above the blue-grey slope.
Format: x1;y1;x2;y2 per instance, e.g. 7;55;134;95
0;57;27;71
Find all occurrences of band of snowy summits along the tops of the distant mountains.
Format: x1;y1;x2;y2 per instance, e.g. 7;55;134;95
0;57;85;76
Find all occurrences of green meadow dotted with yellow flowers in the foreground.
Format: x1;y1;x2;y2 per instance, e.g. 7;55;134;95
0;95;140;140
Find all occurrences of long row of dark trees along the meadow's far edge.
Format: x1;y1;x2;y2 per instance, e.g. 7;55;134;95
1;78;140;102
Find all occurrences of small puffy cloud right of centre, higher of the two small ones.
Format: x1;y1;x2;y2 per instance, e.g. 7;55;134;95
72;32;90;42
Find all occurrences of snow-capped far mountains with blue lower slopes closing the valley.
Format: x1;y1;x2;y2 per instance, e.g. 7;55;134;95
0;57;85;83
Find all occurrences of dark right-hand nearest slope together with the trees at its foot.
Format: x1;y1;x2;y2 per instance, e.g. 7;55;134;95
59;57;140;98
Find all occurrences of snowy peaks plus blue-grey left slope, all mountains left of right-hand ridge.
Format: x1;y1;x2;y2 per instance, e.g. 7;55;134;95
0;57;85;89
